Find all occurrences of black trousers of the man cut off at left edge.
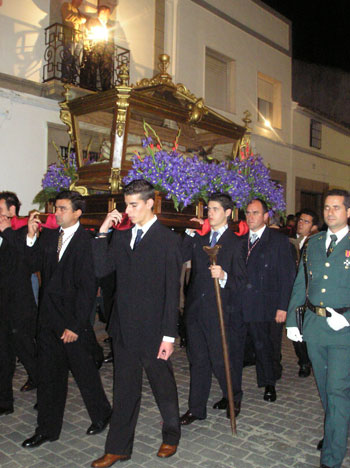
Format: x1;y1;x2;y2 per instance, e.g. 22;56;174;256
0;320;37;409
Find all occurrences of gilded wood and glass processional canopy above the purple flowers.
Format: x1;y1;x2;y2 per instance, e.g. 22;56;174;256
60;54;245;194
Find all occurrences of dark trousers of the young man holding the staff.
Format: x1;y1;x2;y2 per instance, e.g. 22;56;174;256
186;310;242;418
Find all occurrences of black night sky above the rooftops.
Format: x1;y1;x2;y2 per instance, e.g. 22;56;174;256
263;0;350;71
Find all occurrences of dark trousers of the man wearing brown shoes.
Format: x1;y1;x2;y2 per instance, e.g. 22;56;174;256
105;338;180;455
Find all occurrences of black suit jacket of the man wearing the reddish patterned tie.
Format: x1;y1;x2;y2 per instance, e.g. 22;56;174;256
27;225;96;336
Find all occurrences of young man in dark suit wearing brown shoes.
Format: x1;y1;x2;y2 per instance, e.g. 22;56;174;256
92;180;181;468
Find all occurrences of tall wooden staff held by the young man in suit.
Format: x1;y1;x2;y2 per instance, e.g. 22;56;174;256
203;244;237;434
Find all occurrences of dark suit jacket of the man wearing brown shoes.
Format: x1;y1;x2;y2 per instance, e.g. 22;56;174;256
93;221;181;354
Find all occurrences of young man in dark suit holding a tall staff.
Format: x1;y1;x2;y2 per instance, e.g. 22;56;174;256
181;193;246;425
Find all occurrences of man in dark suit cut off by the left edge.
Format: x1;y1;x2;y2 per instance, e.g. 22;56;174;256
0;192;37;415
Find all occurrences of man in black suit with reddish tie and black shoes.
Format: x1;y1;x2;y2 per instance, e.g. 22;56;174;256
10;190;111;448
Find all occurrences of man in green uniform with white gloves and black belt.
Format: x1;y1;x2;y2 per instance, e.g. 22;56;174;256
287;190;350;468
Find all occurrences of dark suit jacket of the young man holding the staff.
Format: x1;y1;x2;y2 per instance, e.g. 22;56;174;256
182;229;247;320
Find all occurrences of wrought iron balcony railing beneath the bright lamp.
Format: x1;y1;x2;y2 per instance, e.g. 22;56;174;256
43;23;130;91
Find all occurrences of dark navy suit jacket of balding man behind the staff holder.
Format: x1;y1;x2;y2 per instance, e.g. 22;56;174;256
242;227;296;322
